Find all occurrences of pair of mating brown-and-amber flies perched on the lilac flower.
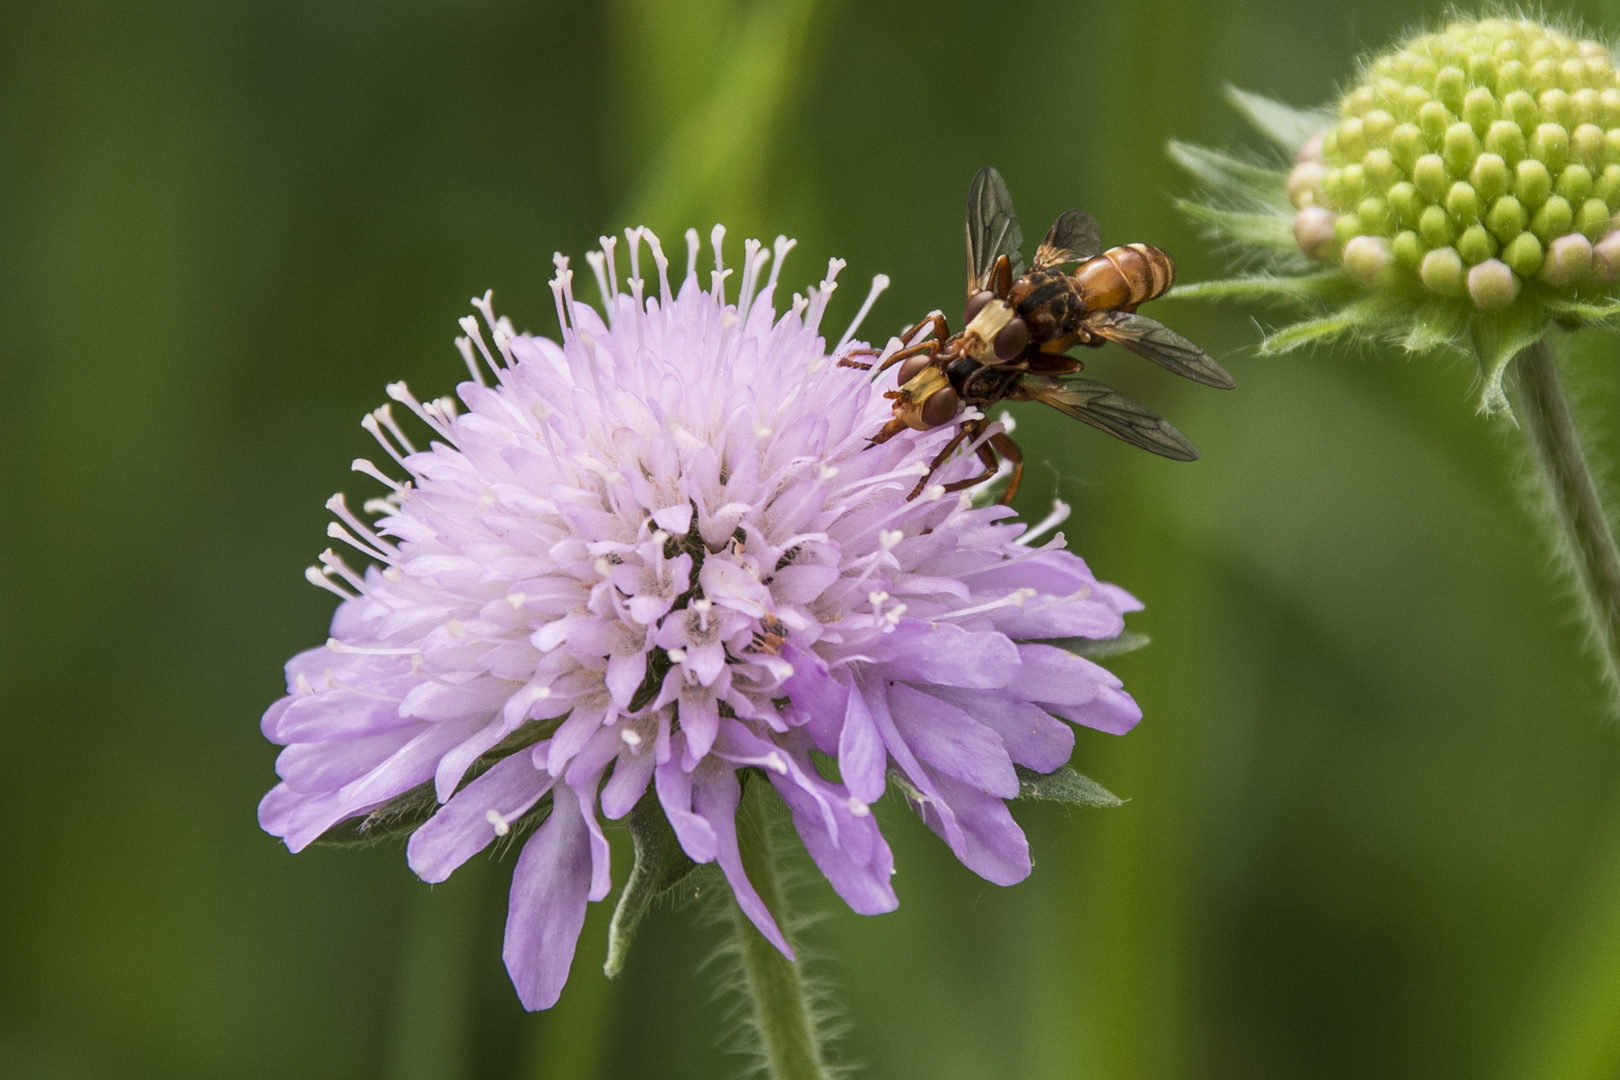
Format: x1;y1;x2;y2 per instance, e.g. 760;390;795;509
841;165;1234;504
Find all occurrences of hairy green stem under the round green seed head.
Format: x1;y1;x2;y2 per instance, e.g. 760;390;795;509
1515;338;1620;705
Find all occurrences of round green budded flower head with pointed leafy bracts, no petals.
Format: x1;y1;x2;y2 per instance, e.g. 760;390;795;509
1171;18;1620;410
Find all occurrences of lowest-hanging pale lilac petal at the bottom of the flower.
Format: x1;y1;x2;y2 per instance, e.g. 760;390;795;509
501;786;591;1012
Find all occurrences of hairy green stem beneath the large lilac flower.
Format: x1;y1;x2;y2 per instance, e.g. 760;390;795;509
731;782;828;1080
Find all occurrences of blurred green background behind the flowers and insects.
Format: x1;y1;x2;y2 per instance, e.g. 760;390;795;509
15;0;1620;1080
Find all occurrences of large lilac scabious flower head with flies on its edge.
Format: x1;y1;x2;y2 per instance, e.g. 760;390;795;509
259;228;1140;1009
